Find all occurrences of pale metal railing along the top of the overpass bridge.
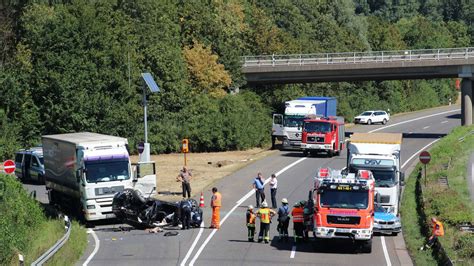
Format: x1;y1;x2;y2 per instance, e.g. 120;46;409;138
242;47;474;67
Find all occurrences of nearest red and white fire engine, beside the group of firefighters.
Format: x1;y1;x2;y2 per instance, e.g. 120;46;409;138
312;168;375;253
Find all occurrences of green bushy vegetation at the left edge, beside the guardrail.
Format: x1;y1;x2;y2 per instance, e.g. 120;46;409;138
0;174;46;265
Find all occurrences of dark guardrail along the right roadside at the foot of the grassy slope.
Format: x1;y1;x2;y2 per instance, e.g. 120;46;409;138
415;168;453;266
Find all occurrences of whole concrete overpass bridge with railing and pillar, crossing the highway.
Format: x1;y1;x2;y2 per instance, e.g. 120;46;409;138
242;47;474;125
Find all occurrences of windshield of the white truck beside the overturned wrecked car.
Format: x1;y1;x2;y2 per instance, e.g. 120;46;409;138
85;159;130;183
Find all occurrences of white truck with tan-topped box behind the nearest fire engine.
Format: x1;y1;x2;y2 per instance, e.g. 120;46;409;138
347;133;405;215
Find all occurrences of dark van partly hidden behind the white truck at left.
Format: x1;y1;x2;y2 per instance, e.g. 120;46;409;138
15;147;44;184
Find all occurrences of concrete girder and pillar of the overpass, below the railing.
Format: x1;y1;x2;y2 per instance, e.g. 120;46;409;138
243;61;474;125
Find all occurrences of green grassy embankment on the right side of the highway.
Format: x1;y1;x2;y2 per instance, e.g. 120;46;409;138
401;126;474;265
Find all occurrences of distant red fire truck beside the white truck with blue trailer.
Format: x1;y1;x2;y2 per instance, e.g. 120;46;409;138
301;115;346;157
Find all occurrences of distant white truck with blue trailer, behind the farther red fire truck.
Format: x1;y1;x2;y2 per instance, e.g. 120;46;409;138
272;97;337;149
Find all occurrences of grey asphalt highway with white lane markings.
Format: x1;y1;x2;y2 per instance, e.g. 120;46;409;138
24;106;461;266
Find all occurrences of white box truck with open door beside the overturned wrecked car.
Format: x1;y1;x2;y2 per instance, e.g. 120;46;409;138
42;132;156;221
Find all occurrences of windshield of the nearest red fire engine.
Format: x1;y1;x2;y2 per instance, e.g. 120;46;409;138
320;190;369;209
